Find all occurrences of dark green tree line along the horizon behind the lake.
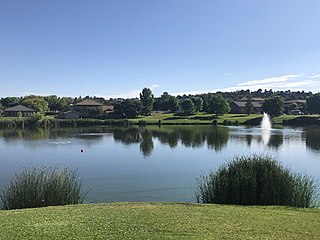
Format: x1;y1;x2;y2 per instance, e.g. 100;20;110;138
0;88;320;118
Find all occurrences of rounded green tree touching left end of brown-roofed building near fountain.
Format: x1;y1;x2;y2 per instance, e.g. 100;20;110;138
207;93;231;115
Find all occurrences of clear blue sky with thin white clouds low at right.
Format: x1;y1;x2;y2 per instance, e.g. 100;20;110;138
0;0;320;98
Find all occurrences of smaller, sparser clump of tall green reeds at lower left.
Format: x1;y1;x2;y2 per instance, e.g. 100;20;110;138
0;166;86;210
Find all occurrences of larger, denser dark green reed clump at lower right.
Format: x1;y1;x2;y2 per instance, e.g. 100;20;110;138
196;155;318;207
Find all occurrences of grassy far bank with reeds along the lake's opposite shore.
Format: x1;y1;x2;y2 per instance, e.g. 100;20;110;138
0;113;320;128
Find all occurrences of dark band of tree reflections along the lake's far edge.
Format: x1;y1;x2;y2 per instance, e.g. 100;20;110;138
0;126;320;154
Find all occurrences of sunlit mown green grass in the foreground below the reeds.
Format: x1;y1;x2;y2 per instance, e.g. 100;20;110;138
0;203;320;240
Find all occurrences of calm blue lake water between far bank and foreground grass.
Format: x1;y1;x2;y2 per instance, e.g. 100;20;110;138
0;126;320;203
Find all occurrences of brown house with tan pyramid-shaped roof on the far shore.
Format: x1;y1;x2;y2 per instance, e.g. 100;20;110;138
70;99;103;118
